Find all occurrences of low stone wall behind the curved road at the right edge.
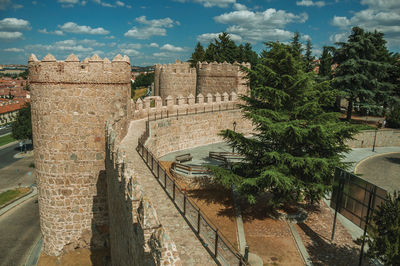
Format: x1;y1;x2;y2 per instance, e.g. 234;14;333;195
347;129;400;148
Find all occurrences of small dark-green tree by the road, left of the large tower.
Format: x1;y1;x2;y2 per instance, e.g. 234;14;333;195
11;103;32;140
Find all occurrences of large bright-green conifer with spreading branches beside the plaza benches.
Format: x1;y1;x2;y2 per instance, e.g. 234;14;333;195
210;42;357;206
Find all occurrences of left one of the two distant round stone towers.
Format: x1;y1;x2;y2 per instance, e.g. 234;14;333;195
154;61;196;98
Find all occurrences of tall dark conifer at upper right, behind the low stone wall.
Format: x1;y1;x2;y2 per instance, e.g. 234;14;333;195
333;27;392;120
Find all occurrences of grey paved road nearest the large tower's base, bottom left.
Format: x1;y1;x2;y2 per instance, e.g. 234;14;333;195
0;196;40;266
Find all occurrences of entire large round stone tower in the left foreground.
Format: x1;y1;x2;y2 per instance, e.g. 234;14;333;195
28;55;131;255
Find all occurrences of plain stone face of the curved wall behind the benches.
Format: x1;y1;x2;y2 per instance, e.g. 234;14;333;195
146;109;253;158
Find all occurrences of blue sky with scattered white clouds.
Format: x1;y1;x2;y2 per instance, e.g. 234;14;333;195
0;0;400;65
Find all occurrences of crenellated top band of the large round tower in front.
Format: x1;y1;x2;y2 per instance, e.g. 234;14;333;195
28;54;131;84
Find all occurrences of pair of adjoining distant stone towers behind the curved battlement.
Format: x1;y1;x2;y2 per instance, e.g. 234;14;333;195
154;60;250;99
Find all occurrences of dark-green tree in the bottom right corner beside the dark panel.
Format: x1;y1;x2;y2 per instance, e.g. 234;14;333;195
367;193;400;265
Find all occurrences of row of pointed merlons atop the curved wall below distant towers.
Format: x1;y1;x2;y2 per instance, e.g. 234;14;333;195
131;92;239;120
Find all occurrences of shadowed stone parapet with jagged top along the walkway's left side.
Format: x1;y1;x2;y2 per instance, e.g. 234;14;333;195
106;123;181;266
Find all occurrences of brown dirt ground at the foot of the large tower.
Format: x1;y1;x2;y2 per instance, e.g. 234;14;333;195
37;248;110;266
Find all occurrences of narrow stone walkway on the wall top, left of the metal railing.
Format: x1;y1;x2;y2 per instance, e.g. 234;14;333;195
121;119;216;265
